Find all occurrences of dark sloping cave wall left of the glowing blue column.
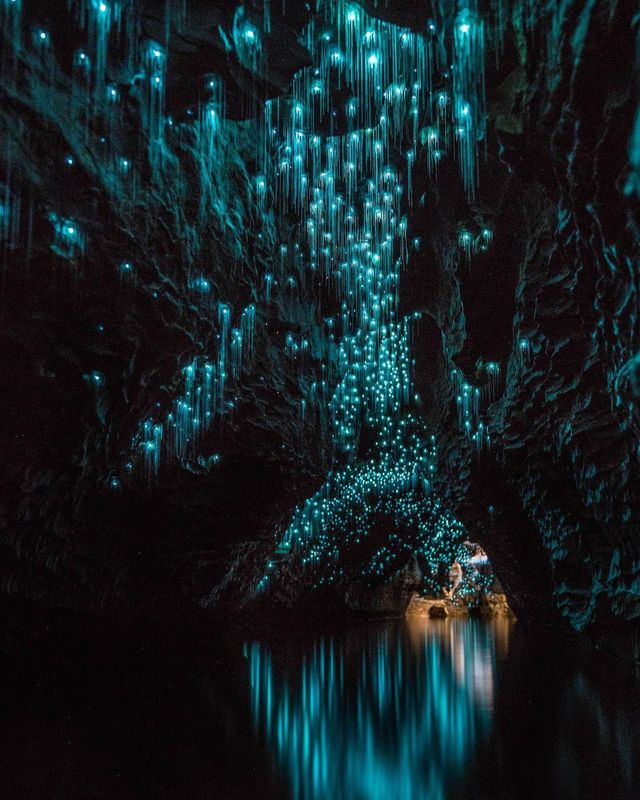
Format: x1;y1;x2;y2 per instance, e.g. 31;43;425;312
0;3;328;608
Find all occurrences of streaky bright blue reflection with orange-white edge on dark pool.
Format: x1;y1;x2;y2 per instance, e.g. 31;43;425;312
247;620;509;800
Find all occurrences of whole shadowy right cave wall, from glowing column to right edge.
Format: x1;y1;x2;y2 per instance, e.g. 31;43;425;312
411;3;640;647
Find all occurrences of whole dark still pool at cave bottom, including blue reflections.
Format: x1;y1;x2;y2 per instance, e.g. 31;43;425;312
0;619;640;800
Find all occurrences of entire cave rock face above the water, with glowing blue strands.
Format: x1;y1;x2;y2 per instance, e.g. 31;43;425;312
0;0;640;656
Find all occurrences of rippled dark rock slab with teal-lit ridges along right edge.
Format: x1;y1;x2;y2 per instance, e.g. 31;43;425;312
472;4;640;648
